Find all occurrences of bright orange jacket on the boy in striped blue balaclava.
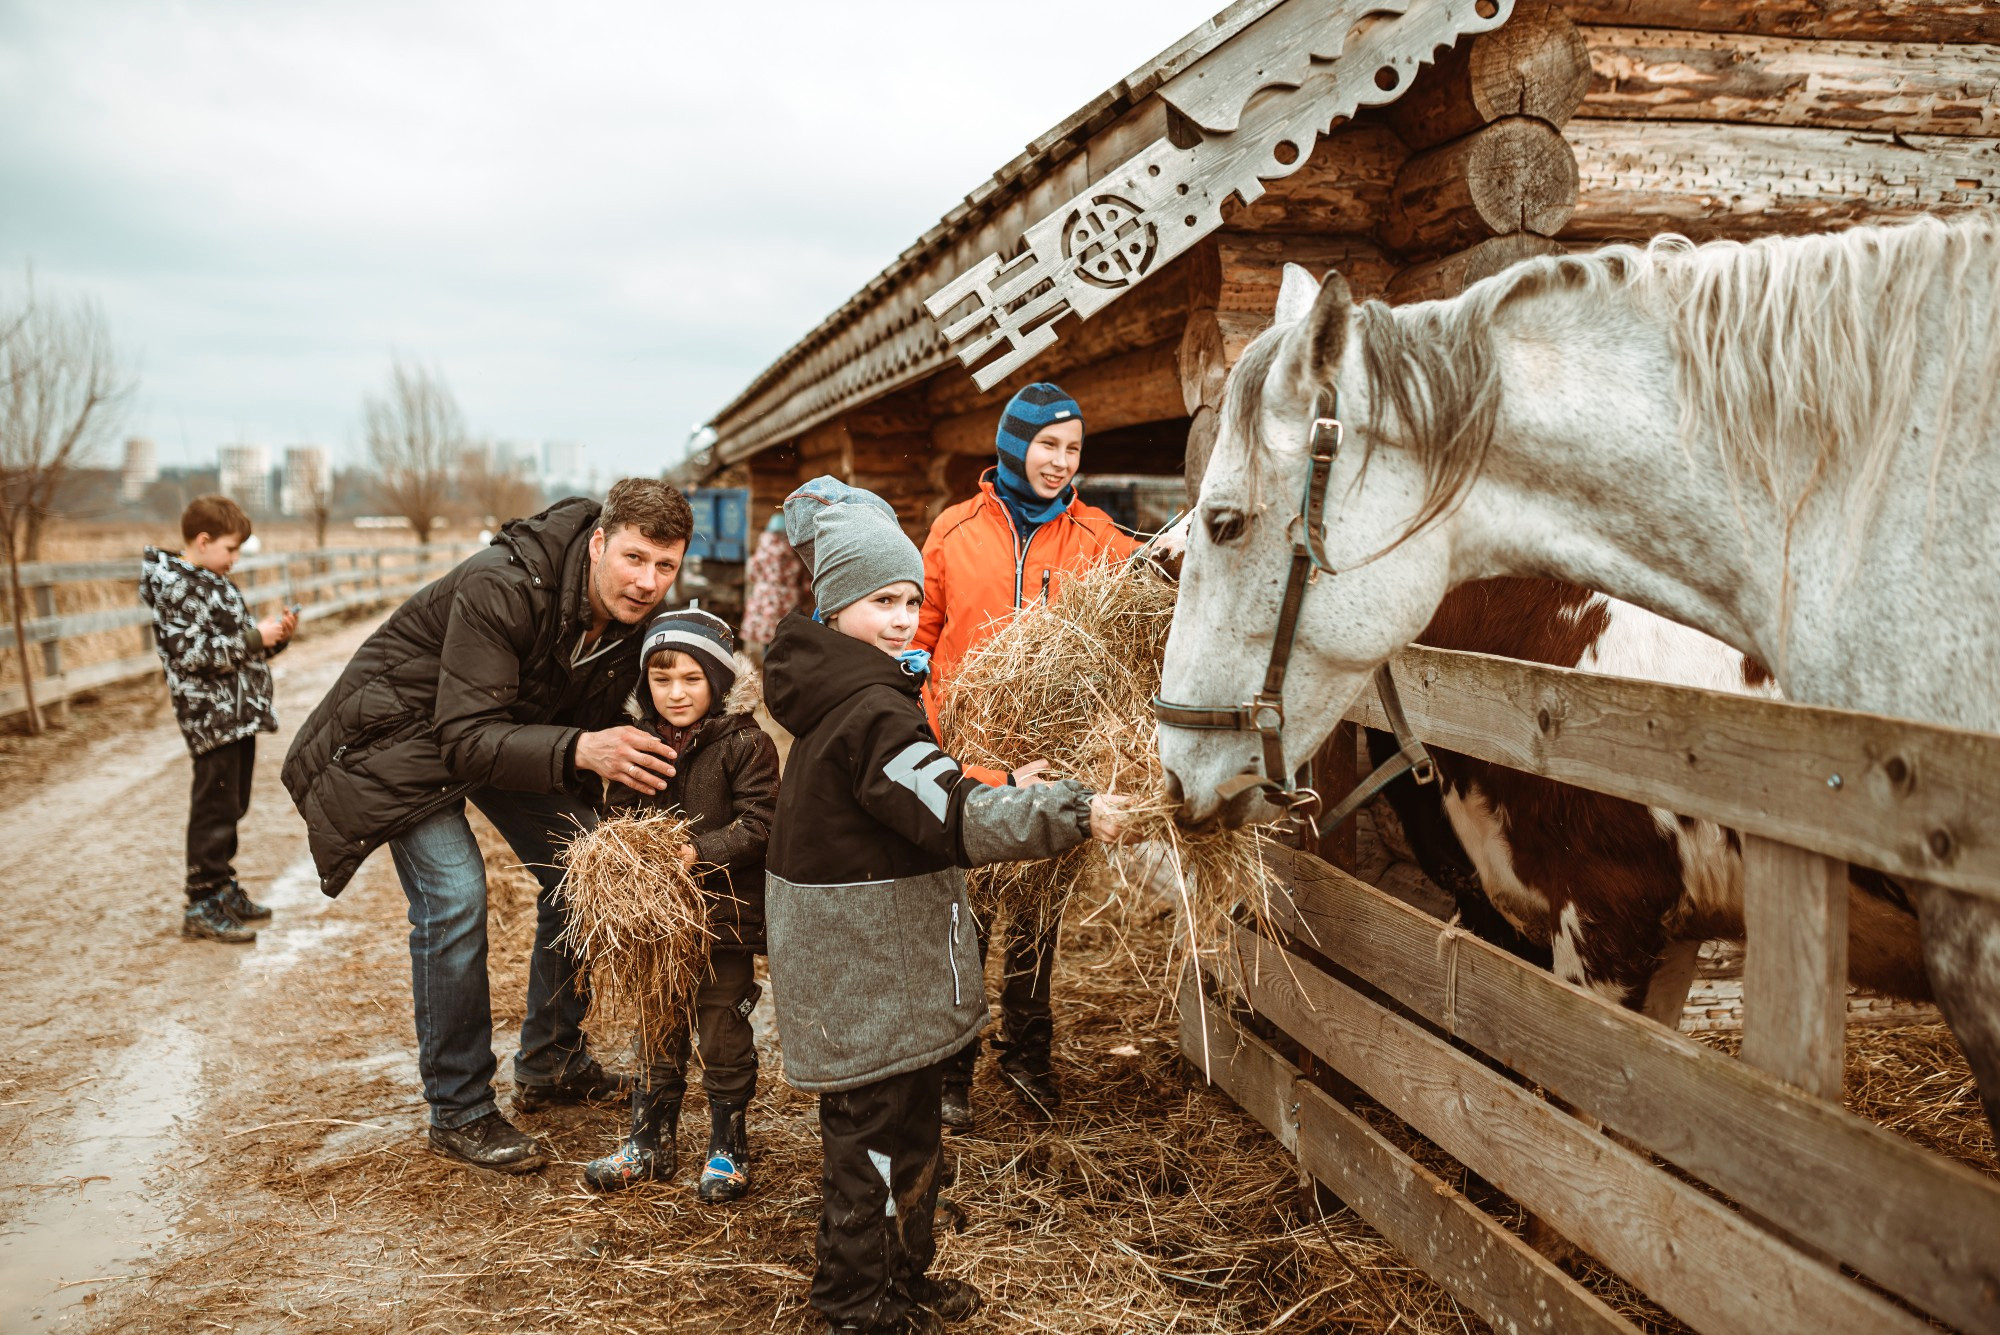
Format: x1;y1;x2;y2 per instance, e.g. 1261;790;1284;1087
916;468;1138;783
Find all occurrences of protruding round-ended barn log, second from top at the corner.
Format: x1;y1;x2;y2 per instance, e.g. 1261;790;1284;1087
1382;116;1578;258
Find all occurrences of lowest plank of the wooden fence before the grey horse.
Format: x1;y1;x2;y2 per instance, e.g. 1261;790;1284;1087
1180;971;1634;1335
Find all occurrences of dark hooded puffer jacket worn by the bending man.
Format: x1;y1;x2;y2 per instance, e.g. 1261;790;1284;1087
284;496;638;895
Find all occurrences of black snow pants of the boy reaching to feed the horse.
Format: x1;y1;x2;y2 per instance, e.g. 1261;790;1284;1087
812;1063;944;1327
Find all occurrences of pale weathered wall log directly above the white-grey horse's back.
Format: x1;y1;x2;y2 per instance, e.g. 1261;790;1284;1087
1562;118;2000;242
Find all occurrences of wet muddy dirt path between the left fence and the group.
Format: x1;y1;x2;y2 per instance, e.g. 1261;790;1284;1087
0;622;402;1331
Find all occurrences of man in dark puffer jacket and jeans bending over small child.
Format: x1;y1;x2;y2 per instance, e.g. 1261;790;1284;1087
284;478;694;1173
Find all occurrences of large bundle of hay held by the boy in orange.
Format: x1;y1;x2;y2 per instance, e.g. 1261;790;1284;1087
938;558;1268;943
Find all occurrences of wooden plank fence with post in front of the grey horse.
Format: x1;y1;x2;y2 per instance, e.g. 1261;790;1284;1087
1182;650;2000;1335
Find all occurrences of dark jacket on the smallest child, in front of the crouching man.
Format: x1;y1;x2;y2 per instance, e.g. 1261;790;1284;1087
592;658;778;953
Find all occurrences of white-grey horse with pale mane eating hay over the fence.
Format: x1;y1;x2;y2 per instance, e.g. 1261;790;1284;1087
1160;214;2000;1127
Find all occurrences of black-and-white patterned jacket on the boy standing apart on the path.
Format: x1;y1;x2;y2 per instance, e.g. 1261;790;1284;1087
138;548;284;755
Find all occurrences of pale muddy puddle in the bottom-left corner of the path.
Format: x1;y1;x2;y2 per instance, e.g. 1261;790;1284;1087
0;1021;202;1331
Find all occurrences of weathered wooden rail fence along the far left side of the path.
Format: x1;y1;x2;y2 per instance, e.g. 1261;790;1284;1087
0;546;466;717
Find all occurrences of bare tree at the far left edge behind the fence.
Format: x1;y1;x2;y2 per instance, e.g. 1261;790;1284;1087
0;280;130;731
